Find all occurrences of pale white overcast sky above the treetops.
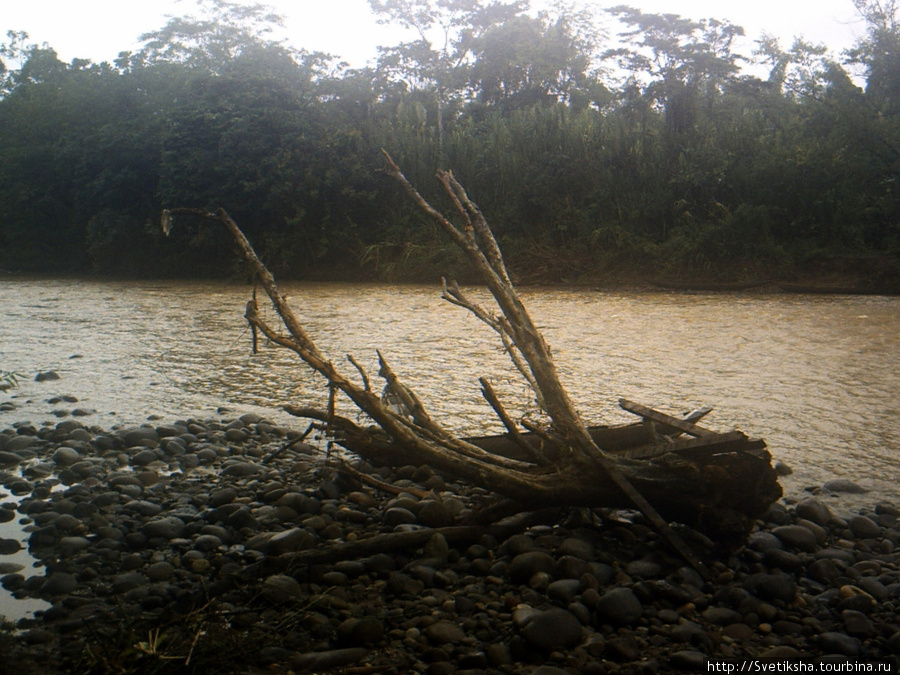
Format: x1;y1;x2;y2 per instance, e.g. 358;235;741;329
0;0;862;66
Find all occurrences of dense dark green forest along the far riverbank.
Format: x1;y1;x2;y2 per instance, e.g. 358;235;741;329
0;0;900;290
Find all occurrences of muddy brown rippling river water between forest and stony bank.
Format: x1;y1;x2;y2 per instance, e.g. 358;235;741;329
0;280;900;499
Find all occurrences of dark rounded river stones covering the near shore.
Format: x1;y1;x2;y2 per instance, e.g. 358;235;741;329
0;414;900;675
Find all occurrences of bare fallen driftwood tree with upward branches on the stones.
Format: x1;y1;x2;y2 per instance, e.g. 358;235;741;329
163;155;781;568
